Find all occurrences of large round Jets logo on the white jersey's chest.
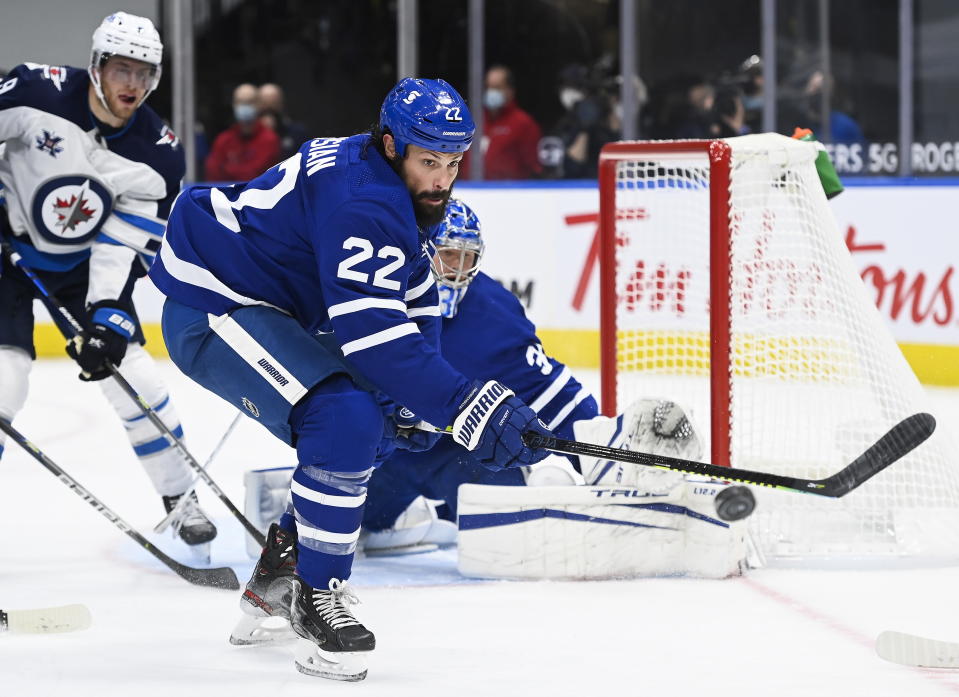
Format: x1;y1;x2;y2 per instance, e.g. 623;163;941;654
30;176;113;245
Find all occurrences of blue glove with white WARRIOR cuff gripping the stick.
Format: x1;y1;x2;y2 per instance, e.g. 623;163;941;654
452;380;552;470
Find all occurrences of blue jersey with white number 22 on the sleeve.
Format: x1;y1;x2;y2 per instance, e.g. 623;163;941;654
150;134;471;426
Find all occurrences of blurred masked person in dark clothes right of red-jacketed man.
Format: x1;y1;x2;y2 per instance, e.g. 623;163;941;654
540;64;622;179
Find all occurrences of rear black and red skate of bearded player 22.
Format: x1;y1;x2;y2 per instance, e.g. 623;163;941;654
230;523;296;646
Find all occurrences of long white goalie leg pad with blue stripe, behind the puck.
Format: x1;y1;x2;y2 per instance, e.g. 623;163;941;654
458;482;746;579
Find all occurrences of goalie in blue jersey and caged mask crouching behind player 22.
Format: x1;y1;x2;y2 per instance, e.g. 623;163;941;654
363;199;701;552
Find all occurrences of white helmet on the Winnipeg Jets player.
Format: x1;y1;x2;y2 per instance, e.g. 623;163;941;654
87;12;163;111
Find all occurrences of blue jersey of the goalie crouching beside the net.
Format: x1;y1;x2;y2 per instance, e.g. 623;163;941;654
442;272;597;431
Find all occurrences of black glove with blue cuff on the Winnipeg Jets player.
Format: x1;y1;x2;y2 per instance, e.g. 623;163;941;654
67;300;136;382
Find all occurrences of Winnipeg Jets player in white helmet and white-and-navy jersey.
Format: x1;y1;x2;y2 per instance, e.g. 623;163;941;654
0;12;216;545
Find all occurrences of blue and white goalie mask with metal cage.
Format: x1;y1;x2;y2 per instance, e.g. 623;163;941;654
430;198;486;318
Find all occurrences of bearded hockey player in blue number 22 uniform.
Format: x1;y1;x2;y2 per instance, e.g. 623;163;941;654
150;78;548;680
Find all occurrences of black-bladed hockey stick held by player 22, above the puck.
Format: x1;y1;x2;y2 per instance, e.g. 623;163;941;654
523;413;936;498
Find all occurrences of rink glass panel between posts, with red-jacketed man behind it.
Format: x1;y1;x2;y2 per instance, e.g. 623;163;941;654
476;0;621;179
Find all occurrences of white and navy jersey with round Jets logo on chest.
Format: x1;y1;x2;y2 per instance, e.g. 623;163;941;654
0;63;186;270
